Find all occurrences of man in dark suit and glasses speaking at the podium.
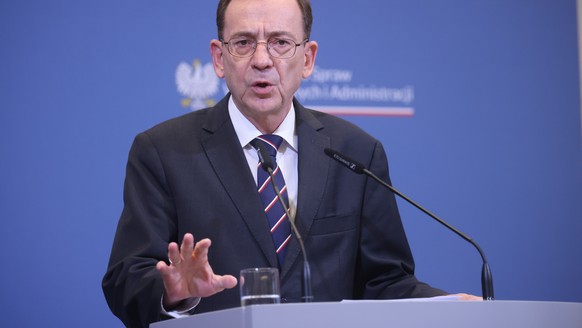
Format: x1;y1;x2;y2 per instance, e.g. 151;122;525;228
103;0;460;327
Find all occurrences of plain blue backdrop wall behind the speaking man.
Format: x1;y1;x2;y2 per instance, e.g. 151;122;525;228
0;0;582;327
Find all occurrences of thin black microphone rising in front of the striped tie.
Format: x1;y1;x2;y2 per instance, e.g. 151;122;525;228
256;142;313;303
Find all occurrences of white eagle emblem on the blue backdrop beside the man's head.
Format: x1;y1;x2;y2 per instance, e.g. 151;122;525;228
176;59;220;110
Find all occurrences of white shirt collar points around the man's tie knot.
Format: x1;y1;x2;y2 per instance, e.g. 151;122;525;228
228;96;297;151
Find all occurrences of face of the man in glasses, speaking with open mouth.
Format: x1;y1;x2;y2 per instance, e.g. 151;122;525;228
211;0;317;132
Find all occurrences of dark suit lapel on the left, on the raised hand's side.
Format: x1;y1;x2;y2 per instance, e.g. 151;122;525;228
202;96;277;267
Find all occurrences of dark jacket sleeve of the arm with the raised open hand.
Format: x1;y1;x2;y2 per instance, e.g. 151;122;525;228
102;133;178;327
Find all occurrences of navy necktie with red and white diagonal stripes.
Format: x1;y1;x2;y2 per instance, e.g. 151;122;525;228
251;134;291;268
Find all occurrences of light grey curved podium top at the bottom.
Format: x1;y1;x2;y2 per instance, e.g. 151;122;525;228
150;300;582;328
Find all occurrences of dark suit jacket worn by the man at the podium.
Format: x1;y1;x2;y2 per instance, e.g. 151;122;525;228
103;97;444;327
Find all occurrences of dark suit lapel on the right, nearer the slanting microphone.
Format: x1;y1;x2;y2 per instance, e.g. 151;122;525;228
281;101;330;279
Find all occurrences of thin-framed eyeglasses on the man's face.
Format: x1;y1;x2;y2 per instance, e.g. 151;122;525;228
221;38;309;59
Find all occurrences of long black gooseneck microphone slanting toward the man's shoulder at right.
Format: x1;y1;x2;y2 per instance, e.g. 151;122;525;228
324;148;494;301
